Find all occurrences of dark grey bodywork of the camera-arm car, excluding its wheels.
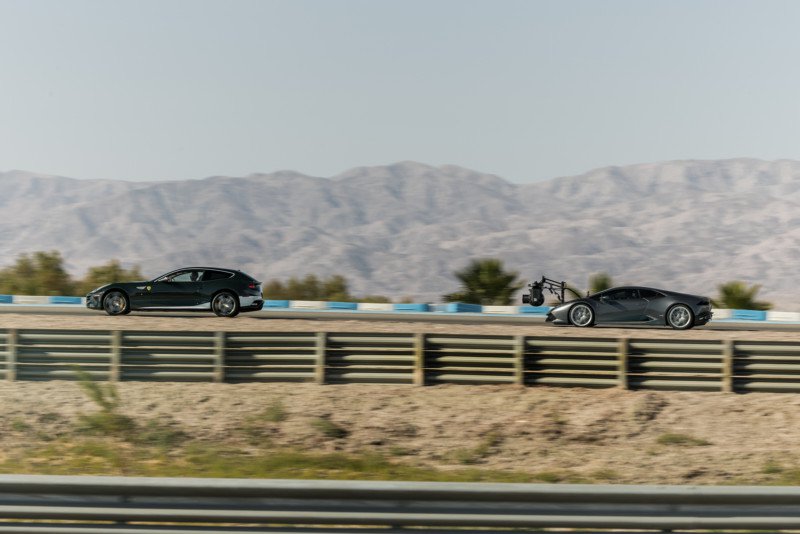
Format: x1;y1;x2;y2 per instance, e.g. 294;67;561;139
547;286;713;328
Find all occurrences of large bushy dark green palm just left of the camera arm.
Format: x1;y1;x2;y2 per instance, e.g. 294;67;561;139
442;258;524;306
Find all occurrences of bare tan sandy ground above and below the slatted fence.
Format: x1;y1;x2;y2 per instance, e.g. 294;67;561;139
0;314;800;484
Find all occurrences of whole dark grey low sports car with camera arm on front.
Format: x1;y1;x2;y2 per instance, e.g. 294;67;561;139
536;286;712;330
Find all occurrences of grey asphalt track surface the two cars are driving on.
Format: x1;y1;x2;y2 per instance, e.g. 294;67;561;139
0;304;800;332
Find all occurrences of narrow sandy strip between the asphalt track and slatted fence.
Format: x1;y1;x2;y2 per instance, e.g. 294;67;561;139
0;313;800;341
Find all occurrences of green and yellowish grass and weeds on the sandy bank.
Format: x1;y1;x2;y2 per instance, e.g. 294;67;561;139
0;369;592;482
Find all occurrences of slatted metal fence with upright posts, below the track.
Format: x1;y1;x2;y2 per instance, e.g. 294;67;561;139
0;329;800;392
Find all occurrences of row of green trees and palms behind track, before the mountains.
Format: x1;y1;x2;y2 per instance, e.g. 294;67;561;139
0;250;772;310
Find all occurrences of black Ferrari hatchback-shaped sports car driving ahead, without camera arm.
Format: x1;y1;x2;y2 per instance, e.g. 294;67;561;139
86;267;264;317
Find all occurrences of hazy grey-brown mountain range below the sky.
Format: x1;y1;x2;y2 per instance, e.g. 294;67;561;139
0;159;800;309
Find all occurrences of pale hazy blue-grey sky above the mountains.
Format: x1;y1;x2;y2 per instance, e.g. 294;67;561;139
0;0;800;182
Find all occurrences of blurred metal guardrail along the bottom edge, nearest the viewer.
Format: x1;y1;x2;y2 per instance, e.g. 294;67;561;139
0;475;800;534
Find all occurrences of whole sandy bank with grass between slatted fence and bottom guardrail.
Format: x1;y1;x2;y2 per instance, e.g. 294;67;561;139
0;375;800;485
